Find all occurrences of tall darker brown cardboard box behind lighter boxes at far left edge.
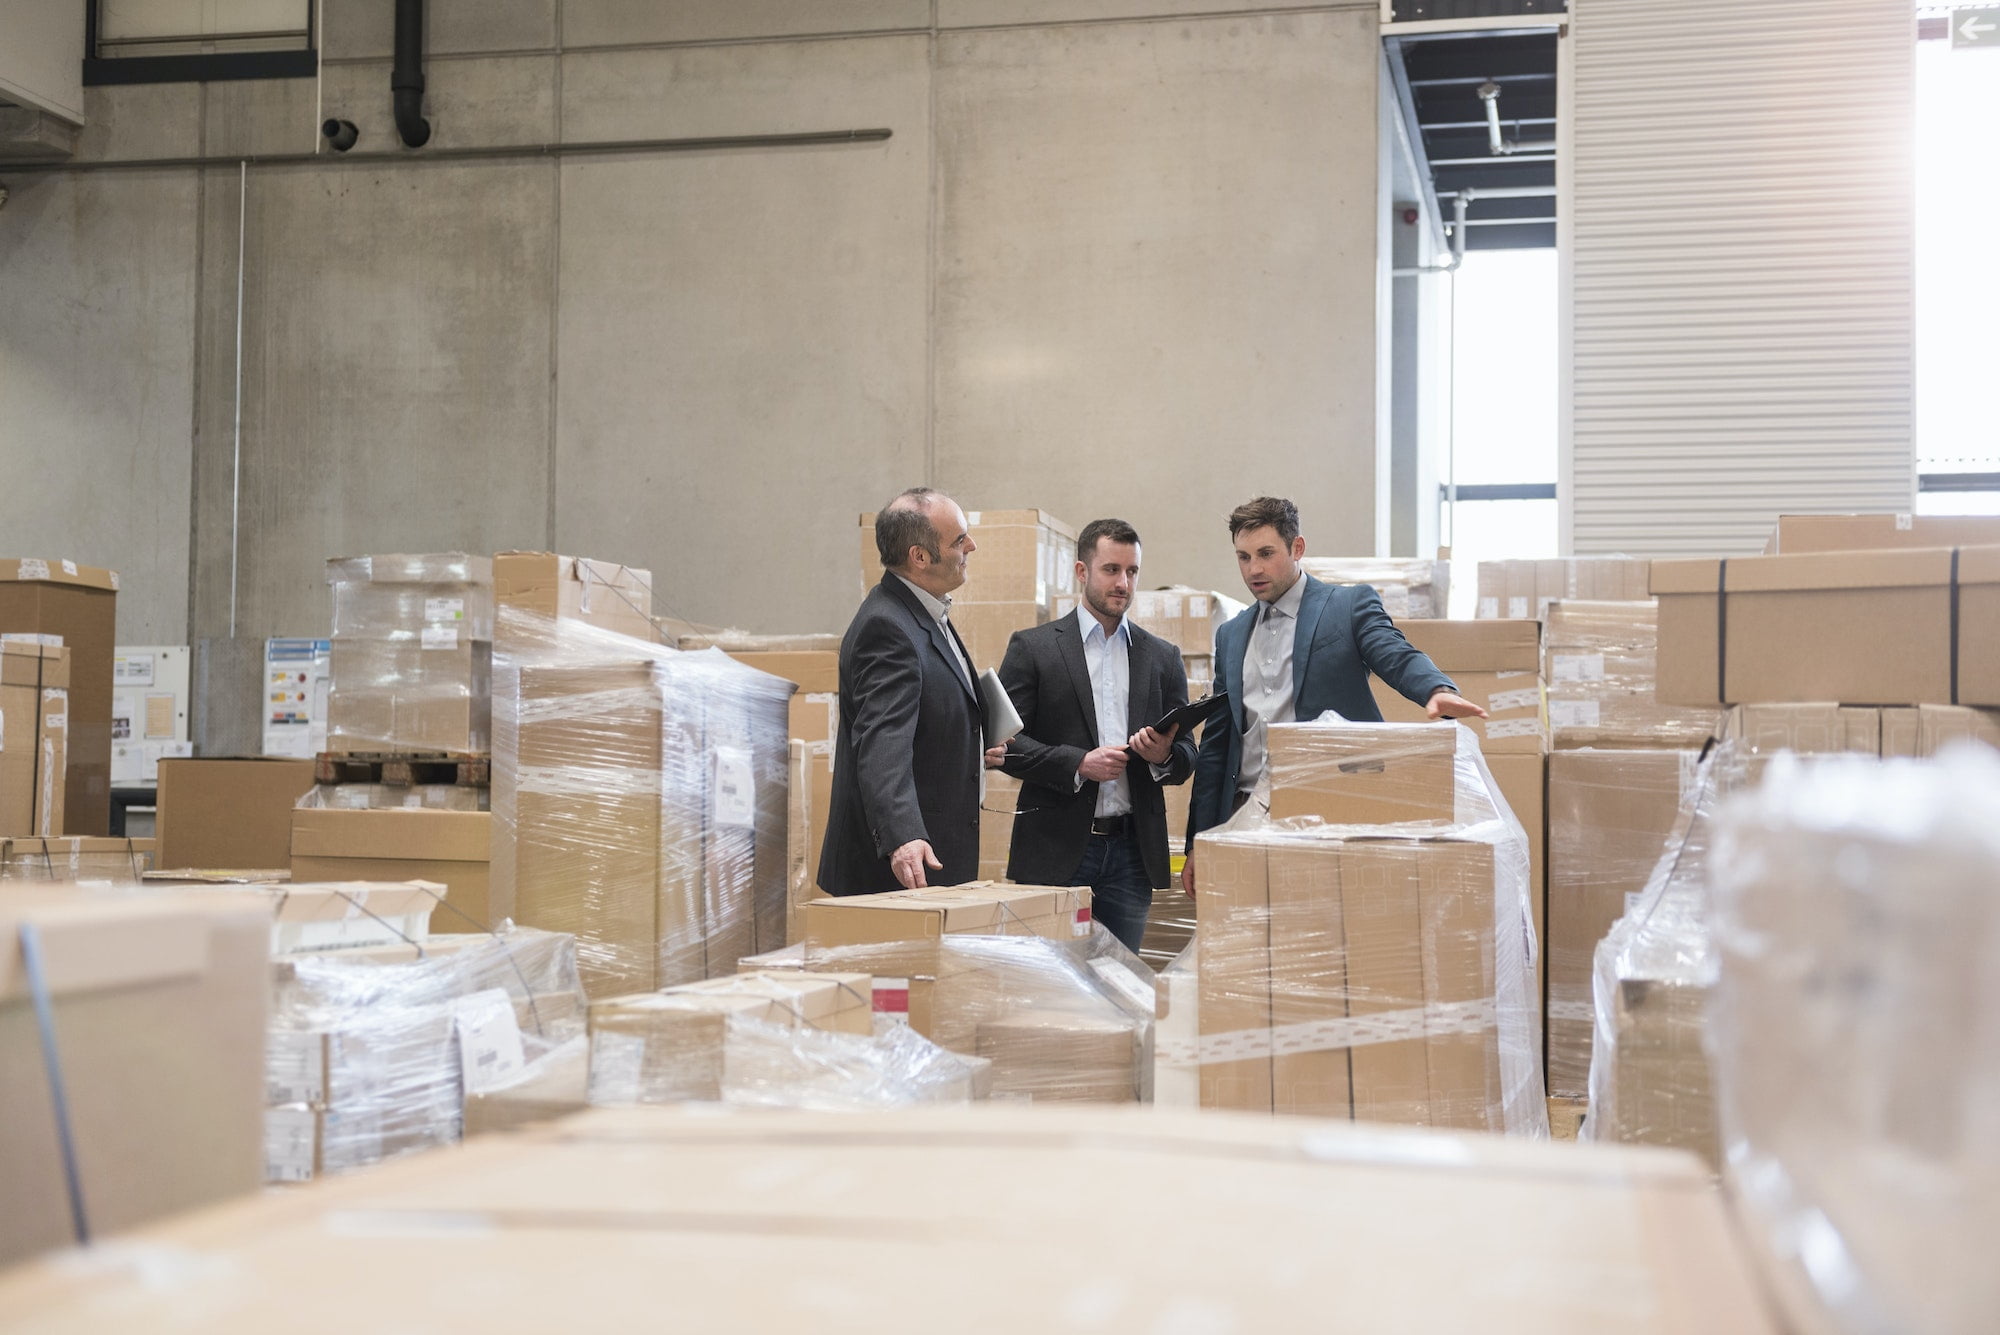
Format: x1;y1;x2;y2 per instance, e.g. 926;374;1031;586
0;558;118;837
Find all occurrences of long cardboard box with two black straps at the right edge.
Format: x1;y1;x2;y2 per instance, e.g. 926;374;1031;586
1652;548;2000;705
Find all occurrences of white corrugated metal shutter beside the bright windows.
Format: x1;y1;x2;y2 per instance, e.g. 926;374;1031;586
1564;0;1916;556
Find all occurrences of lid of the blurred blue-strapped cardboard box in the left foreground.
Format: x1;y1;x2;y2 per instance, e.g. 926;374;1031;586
0;889;250;1003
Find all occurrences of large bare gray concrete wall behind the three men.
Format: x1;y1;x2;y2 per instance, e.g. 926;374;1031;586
0;0;1378;642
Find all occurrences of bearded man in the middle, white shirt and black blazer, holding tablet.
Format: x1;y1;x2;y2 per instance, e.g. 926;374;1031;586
1000;520;1194;951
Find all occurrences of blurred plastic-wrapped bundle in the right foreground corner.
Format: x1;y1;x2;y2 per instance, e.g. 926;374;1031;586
1710;745;2000;1335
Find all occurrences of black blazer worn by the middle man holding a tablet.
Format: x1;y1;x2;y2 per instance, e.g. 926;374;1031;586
1000;612;1194;889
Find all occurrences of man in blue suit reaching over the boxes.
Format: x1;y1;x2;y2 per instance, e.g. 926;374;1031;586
1182;496;1486;895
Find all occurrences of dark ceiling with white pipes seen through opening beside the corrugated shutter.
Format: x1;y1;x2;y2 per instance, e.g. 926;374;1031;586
1388;28;1558;250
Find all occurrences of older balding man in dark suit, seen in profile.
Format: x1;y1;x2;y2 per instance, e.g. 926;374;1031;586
820;488;1000;895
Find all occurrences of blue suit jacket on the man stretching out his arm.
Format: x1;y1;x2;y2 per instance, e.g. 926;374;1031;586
1188;576;1458;849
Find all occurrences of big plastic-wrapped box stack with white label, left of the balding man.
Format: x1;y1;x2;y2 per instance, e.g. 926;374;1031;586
492;608;794;997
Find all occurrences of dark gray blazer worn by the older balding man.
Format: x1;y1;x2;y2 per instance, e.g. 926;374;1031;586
820;574;984;895
